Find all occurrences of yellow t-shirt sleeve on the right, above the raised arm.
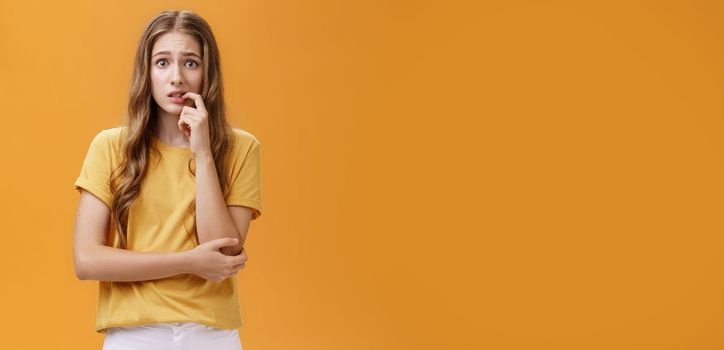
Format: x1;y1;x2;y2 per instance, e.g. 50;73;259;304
226;139;262;220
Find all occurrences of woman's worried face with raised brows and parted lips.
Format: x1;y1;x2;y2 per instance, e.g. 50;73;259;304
151;32;203;116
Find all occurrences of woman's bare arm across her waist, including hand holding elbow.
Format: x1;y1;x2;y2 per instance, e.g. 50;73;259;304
73;190;247;282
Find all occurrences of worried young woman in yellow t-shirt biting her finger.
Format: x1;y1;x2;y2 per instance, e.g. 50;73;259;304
73;11;261;350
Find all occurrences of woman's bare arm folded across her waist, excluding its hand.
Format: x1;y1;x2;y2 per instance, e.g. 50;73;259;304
73;190;193;282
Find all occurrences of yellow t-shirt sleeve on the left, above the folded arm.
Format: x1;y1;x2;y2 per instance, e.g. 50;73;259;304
75;131;112;208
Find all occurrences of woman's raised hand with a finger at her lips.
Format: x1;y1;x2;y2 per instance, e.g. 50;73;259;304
178;91;213;158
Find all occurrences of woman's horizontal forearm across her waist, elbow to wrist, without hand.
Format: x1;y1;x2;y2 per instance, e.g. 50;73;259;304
78;245;191;282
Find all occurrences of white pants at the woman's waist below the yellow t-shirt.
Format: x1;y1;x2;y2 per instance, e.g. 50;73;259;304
103;322;242;350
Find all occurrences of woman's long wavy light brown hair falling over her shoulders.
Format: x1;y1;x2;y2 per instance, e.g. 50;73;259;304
110;11;232;249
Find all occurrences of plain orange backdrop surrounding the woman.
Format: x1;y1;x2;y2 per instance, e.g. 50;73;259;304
0;0;724;350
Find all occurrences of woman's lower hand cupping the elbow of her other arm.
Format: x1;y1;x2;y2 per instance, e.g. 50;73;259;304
188;238;247;282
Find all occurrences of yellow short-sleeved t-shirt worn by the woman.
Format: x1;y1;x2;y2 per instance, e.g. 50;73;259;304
75;126;261;334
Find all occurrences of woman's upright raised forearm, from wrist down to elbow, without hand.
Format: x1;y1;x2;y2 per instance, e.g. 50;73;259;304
196;156;244;255
